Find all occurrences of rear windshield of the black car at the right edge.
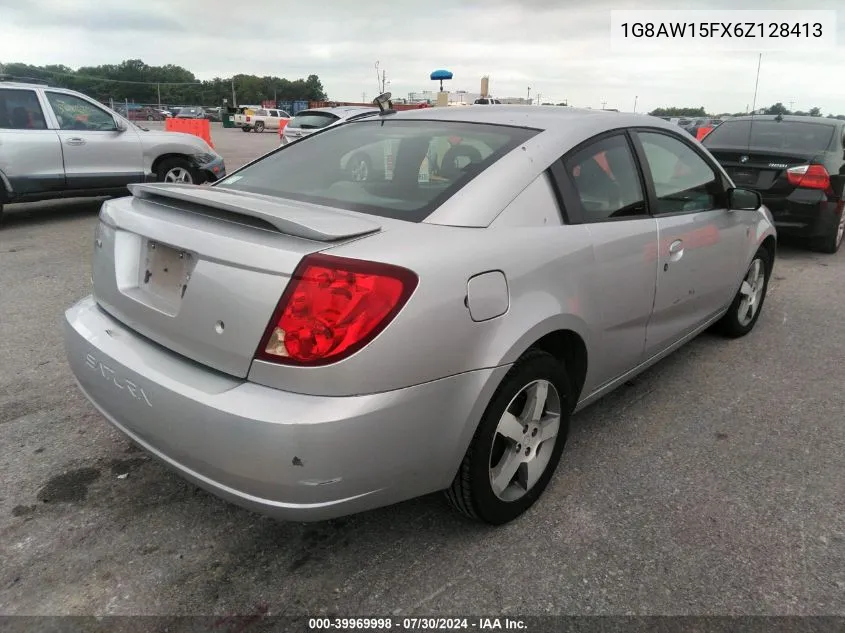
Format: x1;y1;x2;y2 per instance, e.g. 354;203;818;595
703;119;834;152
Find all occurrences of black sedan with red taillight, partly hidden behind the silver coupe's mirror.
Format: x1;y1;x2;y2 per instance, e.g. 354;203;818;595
702;115;845;253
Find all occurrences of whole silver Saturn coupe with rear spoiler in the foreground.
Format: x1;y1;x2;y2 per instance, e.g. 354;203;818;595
65;106;776;524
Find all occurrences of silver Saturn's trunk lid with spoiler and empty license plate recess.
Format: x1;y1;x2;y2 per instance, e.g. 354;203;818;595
92;185;381;378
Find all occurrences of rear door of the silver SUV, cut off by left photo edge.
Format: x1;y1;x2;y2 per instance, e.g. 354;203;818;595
0;87;65;195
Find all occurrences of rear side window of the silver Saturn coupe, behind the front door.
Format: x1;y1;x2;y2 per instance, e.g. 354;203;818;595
565;134;646;222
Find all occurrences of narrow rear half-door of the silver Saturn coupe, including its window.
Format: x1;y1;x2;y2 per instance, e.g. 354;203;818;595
551;131;658;388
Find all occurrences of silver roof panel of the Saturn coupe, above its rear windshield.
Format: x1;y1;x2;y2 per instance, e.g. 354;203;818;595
380;105;677;131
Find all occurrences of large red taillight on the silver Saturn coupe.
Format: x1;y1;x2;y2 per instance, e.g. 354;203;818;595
256;254;418;366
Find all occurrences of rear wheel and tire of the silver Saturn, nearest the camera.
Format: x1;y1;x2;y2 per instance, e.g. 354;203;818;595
446;350;573;525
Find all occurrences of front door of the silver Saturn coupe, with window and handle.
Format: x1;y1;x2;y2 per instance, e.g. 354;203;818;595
635;129;753;357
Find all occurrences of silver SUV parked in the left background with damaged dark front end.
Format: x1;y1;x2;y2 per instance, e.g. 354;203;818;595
0;81;226;221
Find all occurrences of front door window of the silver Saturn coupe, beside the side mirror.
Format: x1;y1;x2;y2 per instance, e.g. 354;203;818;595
638;132;725;215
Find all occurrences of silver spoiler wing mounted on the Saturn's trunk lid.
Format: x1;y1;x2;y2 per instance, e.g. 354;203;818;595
128;183;381;242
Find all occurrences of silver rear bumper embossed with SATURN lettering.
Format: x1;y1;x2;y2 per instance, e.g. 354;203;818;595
65;297;507;521
